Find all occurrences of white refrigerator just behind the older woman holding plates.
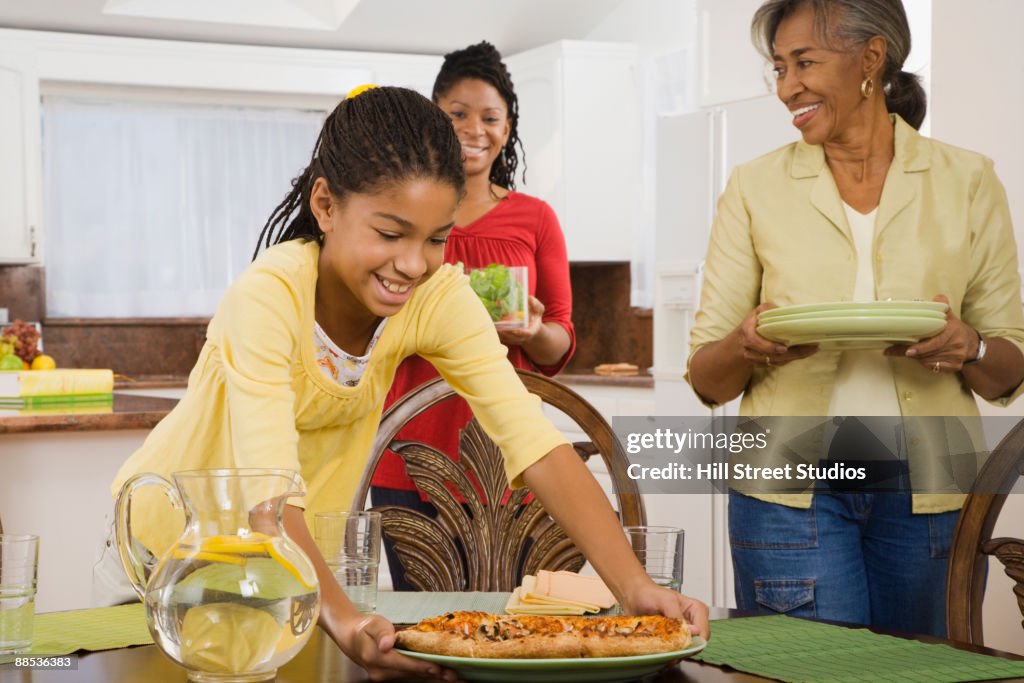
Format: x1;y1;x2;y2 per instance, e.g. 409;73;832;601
645;96;799;606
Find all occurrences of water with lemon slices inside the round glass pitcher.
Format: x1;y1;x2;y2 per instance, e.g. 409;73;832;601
146;537;318;681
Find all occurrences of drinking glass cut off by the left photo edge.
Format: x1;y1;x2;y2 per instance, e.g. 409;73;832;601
0;533;39;654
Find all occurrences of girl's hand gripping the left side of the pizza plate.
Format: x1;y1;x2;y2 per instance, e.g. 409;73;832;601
338;614;457;681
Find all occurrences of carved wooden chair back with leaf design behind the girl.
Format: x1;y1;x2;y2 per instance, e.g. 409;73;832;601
352;370;646;592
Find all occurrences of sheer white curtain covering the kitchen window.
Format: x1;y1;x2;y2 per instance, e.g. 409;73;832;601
43;97;324;317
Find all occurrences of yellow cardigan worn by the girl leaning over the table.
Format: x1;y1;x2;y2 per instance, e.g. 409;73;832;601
111;241;566;553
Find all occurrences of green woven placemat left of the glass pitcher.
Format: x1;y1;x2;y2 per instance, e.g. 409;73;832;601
0;602;153;664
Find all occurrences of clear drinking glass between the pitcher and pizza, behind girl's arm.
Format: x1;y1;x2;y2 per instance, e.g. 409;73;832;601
313;510;381;614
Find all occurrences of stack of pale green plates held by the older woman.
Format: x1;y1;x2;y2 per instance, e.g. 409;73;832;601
758;301;948;350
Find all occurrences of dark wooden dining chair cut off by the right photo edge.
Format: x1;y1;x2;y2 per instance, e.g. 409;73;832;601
946;420;1024;645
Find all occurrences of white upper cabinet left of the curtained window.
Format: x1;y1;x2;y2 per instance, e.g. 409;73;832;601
0;48;42;263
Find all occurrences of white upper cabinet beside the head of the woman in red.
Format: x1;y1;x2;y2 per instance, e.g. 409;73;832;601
506;41;642;261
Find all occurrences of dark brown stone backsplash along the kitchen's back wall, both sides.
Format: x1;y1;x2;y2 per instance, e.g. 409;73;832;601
0;263;653;377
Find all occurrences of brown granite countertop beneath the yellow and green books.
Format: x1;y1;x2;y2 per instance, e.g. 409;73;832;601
0;392;178;434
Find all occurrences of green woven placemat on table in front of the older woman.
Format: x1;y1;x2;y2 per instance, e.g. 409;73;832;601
694;615;1024;683
